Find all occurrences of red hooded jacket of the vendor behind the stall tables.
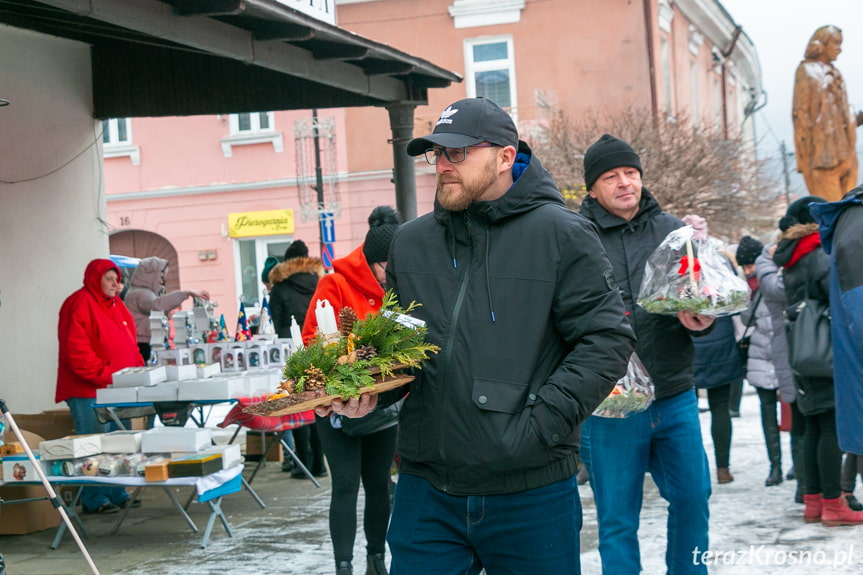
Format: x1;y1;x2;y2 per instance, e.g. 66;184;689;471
54;259;144;403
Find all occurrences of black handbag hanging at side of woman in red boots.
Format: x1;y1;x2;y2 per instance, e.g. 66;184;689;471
785;294;833;378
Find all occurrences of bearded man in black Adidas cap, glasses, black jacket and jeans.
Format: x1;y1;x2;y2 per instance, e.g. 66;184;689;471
324;98;633;575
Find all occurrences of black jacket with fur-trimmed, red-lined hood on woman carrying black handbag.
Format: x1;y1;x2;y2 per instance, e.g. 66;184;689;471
773;224;836;415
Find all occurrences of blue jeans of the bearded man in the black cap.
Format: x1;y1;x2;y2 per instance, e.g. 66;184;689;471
387;475;581;575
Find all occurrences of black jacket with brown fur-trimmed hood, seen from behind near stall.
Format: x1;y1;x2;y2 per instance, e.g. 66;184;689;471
268;257;324;338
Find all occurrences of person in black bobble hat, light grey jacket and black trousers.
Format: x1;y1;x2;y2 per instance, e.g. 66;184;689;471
735;236;784;487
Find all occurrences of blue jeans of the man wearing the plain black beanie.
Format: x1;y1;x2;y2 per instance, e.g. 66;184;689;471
581;392;710;575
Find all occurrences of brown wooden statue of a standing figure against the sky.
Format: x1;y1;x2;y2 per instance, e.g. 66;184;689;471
792;26;863;202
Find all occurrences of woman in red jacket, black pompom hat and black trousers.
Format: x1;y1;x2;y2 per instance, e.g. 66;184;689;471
303;206;399;575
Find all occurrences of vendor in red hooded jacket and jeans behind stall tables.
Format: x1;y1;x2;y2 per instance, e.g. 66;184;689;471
54;259;144;513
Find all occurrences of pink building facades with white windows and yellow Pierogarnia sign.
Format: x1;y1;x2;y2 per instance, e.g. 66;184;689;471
103;0;761;324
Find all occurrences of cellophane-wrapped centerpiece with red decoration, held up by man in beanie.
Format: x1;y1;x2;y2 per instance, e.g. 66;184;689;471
638;226;749;317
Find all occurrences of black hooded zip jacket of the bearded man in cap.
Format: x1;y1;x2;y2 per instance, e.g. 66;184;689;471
387;142;634;495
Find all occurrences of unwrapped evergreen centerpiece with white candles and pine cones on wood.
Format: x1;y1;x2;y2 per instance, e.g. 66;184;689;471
244;291;439;415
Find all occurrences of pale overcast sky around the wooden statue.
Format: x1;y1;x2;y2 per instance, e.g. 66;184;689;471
720;0;863;187
